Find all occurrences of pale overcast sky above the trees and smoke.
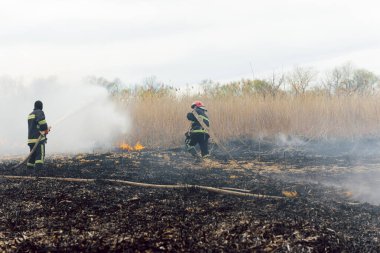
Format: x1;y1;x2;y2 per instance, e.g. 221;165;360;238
0;0;380;86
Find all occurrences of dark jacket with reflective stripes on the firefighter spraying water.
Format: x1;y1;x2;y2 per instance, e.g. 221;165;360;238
28;109;48;144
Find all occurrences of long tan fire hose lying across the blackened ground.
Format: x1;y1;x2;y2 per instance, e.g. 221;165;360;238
1;175;284;199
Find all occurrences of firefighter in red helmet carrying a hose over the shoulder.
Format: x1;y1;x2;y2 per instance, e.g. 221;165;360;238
185;101;210;158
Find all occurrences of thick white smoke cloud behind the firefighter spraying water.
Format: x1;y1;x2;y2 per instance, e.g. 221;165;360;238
0;77;129;157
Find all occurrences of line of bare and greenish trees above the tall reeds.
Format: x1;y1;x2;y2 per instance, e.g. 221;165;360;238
88;63;380;98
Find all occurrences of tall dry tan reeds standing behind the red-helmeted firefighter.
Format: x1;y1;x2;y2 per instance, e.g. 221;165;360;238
116;94;380;147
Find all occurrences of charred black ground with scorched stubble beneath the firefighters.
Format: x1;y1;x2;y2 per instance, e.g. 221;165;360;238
0;141;380;252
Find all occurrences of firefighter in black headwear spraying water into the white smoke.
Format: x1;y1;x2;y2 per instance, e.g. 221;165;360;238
27;101;50;170
